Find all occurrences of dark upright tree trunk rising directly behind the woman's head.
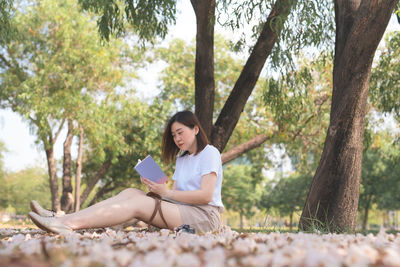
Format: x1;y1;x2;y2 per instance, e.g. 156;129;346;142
191;0;215;136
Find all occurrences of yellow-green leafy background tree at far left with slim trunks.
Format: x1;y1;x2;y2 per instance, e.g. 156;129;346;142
0;1;143;214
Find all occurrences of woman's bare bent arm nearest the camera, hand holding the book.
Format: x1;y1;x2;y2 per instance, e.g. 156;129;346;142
143;172;217;205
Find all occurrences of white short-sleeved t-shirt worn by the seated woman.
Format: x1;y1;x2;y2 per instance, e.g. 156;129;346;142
172;145;224;207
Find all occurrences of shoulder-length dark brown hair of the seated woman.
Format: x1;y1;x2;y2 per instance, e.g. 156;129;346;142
162;110;208;163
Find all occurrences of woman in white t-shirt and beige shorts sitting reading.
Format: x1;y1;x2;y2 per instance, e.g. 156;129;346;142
29;111;223;234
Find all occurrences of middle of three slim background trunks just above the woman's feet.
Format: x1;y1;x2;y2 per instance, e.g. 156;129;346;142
61;121;74;213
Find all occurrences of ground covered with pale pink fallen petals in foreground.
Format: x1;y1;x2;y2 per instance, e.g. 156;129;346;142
0;228;400;267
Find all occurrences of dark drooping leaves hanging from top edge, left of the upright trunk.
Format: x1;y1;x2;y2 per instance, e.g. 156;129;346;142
79;0;176;41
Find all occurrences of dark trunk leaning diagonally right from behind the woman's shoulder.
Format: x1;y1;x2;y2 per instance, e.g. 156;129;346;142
211;0;291;151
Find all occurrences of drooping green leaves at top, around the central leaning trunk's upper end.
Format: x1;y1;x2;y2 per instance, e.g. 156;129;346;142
217;0;335;72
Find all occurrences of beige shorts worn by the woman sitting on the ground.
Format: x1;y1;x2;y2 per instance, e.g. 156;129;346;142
164;199;224;234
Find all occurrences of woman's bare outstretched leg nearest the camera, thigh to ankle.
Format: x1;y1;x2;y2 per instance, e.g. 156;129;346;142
57;188;182;230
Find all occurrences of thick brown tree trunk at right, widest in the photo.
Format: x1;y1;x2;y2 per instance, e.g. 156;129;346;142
300;0;398;231
